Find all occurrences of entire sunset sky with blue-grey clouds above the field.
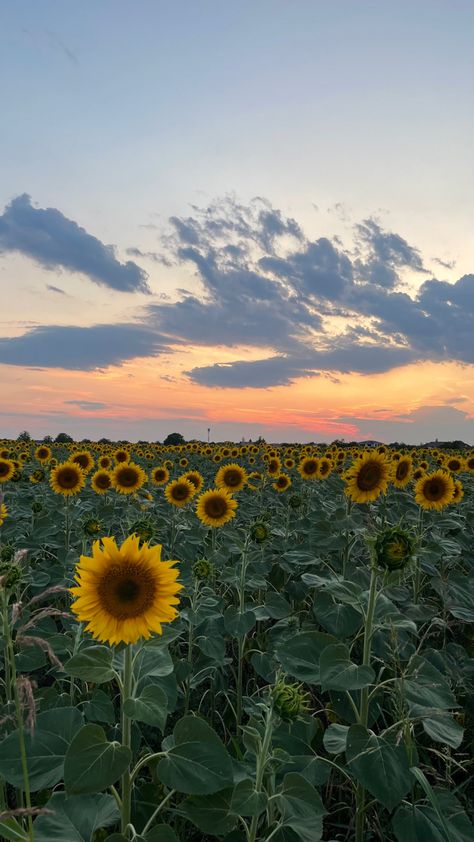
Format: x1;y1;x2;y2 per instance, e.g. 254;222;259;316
0;0;474;444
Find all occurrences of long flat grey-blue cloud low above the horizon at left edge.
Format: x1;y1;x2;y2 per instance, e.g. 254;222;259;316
0;324;168;371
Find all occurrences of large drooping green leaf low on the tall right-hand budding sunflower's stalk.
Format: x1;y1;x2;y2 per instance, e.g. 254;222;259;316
346;725;412;810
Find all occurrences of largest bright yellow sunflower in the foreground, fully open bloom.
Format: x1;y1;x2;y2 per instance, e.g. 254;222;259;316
70;535;183;646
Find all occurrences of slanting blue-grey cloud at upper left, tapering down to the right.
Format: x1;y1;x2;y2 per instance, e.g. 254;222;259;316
0;193;149;293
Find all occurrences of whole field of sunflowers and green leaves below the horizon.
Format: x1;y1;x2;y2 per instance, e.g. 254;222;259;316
0;440;474;842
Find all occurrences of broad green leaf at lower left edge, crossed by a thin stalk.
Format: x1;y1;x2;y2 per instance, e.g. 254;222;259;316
0;708;84;792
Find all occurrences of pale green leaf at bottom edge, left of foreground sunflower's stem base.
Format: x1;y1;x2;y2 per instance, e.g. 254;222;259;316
33;792;119;842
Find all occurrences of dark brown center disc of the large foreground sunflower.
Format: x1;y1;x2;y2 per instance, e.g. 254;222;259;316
98;564;156;620
